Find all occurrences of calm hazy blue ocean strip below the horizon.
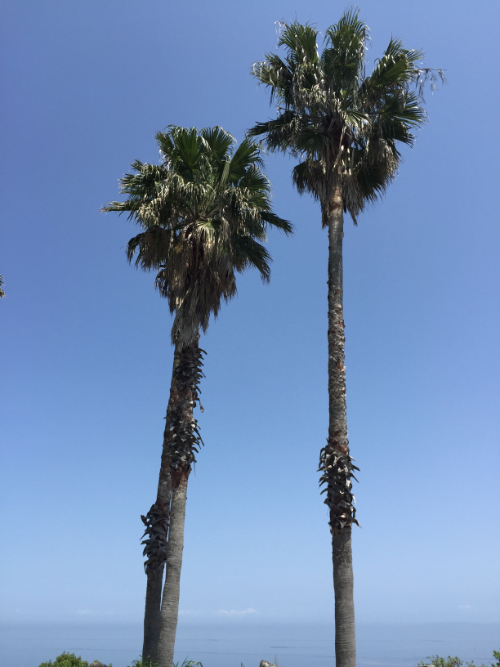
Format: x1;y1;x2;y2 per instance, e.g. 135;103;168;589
0;623;500;667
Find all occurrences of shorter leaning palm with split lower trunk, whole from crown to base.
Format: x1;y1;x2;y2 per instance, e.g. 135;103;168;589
103;126;292;667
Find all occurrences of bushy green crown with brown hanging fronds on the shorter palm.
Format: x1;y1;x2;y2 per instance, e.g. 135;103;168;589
103;126;292;344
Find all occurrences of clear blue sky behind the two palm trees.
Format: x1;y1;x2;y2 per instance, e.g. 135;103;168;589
0;0;500;623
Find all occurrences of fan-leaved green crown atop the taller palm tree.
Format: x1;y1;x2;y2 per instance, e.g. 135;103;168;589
249;10;442;225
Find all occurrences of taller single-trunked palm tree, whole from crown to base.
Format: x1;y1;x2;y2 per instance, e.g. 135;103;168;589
249;10;442;667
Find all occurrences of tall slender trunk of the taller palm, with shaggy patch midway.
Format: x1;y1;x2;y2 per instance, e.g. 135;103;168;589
326;179;356;667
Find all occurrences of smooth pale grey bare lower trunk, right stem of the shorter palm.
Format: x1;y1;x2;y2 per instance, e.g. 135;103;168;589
156;468;190;667
